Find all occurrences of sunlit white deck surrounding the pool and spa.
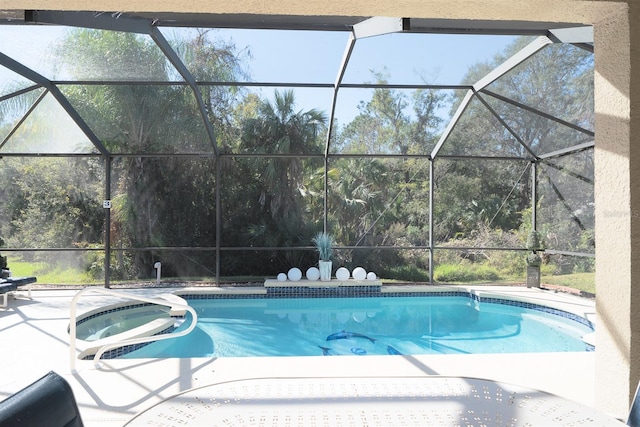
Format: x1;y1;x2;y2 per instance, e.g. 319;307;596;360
0;286;612;427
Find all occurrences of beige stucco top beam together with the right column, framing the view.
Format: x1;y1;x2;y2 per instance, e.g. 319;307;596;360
0;0;640;417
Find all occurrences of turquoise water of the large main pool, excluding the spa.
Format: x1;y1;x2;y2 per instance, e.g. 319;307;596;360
122;296;593;358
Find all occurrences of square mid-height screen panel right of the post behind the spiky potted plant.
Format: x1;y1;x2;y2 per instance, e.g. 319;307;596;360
328;158;429;247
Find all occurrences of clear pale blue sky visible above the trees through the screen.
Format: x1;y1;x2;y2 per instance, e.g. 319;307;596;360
0;26;514;124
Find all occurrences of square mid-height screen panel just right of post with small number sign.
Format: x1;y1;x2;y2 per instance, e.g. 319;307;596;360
111;156;216;244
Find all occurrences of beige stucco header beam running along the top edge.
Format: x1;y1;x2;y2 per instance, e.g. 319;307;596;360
0;0;633;23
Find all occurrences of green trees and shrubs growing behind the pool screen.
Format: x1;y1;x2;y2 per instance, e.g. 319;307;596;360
0;30;594;281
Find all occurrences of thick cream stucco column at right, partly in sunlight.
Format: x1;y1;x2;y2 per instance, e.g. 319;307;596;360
594;2;640;418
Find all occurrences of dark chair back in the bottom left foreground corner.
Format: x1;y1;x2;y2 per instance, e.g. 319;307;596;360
0;371;83;427
